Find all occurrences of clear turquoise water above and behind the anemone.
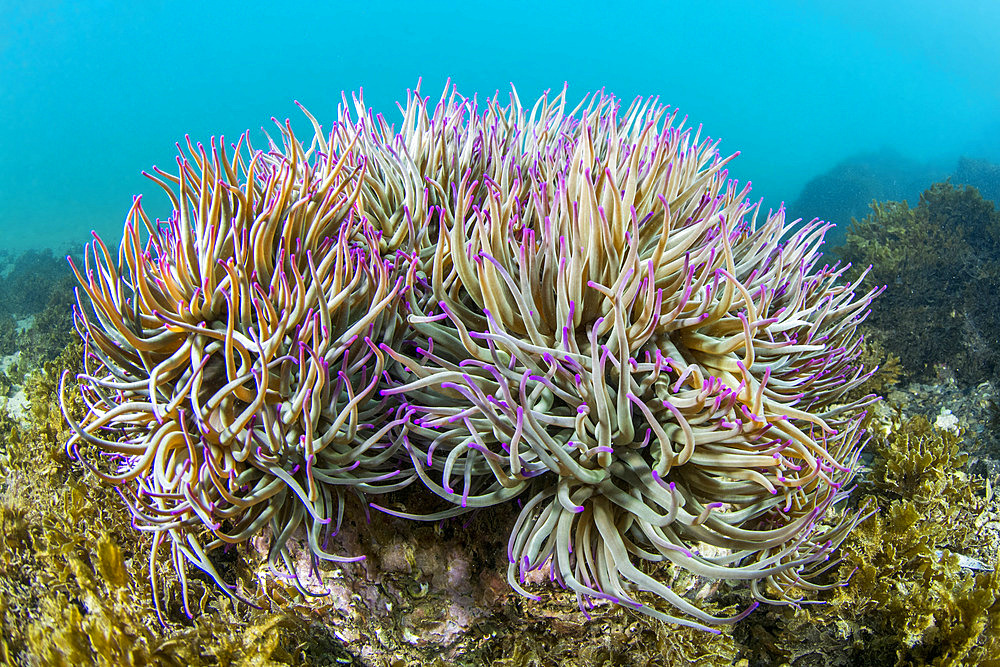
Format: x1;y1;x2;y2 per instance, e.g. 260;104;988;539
0;0;1000;250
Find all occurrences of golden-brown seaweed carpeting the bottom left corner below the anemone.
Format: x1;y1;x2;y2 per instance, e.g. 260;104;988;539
0;342;360;667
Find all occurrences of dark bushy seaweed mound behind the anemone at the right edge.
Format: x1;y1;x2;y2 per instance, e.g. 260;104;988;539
838;183;1000;384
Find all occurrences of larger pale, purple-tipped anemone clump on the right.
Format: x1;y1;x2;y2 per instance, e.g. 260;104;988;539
372;87;875;627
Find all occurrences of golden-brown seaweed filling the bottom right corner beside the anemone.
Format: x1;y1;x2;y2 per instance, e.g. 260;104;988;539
716;411;1000;667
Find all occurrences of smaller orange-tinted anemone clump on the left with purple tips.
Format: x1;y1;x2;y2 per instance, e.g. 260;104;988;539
63;120;412;621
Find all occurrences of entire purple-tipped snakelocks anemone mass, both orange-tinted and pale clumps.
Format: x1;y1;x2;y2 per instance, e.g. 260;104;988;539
62;82;877;627
